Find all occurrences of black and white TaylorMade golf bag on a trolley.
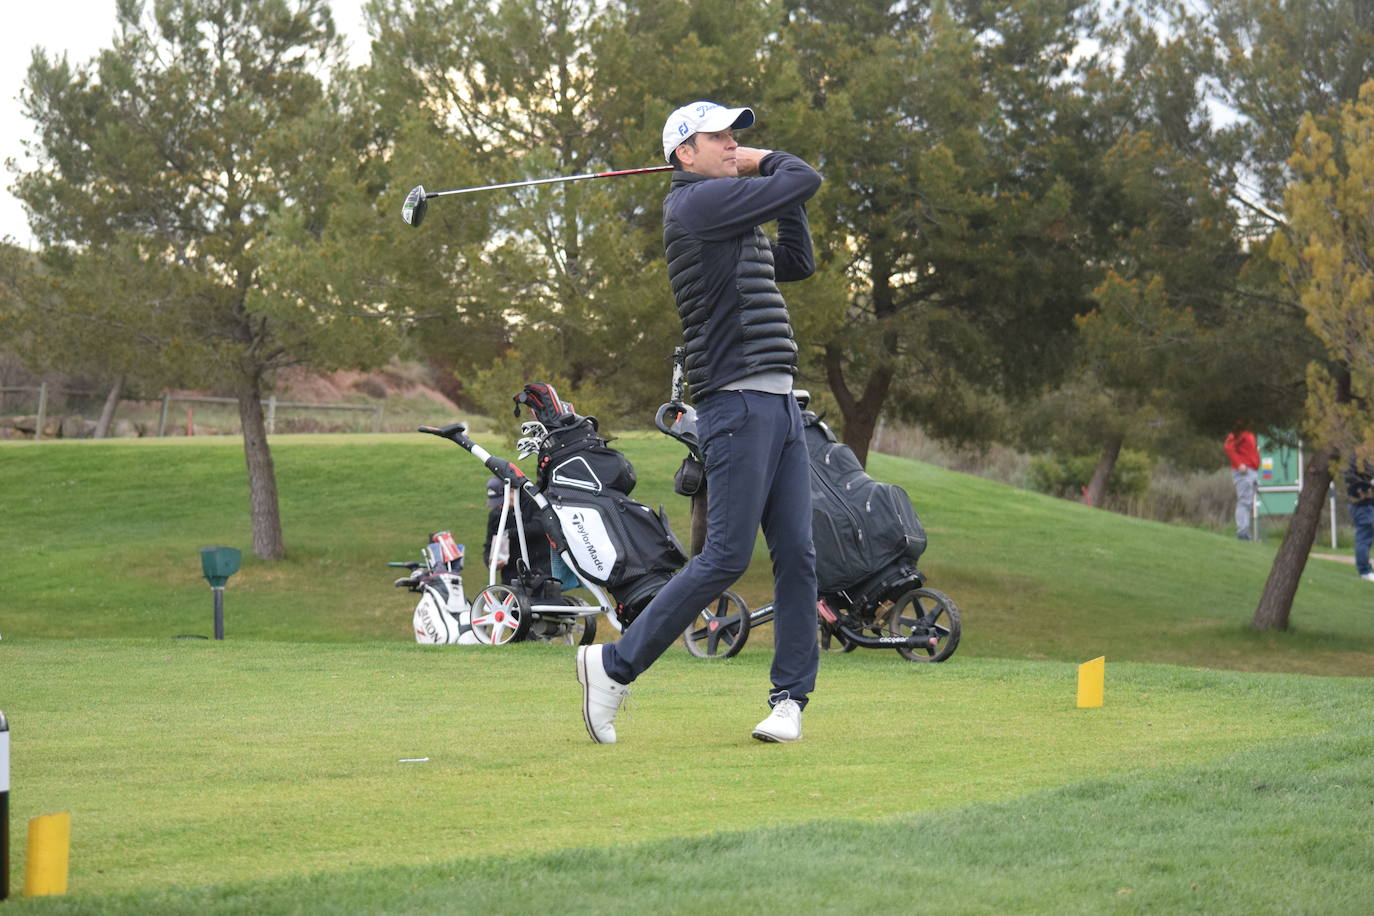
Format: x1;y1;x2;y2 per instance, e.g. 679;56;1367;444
515;385;687;628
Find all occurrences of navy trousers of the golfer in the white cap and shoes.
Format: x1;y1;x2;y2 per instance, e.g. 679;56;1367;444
602;391;820;706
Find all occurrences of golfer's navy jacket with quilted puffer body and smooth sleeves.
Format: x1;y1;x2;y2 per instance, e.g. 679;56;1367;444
664;152;820;398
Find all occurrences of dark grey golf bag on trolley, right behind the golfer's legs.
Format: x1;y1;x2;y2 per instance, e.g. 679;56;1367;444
802;411;926;593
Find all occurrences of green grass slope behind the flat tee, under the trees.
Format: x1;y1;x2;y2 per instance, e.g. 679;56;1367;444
0;434;1374;674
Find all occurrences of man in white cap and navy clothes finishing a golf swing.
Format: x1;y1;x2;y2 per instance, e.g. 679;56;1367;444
577;102;820;744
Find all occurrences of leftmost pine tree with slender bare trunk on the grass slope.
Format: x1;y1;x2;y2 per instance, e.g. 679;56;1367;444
15;0;393;559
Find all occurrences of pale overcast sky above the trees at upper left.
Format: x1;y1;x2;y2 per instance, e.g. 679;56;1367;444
0;0;368;246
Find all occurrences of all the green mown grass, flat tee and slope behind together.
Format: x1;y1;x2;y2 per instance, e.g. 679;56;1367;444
0;435;1374;913
